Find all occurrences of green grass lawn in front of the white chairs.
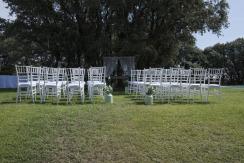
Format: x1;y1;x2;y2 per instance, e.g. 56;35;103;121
0;88;244;162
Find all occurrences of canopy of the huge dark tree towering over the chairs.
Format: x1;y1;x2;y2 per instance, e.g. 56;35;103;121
0;0;228;68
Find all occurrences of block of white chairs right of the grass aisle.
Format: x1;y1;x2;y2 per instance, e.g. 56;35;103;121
129;68;223;102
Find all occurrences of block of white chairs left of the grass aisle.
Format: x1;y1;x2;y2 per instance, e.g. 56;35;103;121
15;65;106;103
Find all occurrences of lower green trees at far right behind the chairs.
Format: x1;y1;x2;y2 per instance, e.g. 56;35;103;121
176;38;244;84
